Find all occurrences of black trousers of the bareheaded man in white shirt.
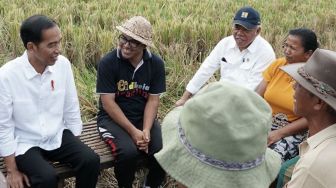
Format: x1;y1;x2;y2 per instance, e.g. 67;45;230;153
15;130;100;188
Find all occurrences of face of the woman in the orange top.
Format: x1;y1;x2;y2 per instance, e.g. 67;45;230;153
283;35;311;63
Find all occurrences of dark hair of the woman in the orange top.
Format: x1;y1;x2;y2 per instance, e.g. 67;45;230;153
289;28;319;52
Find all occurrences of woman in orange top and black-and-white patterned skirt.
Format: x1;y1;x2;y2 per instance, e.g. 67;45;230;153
256;28;318;162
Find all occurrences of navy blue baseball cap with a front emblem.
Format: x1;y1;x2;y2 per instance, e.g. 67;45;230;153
233;6;261;30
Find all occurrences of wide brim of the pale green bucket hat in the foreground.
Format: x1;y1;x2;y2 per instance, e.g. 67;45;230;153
155;107;281;188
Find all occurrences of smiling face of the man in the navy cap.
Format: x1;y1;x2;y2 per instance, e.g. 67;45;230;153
233;24;260;50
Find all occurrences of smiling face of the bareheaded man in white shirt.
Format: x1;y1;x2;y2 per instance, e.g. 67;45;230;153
27;26;62;73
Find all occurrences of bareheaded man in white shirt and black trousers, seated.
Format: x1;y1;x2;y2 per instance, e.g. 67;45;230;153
0;15;99;188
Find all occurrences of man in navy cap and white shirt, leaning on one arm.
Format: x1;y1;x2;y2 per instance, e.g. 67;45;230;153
175;6;275;106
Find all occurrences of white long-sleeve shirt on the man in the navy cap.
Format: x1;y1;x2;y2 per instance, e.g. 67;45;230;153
186;35;275;94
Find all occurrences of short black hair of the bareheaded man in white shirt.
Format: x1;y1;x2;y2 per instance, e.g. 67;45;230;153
20;15;57;49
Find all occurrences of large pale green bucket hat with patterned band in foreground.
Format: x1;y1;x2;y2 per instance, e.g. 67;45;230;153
155;82;281;188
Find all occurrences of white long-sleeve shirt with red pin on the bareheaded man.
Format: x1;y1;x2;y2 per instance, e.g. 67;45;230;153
0;52;82;156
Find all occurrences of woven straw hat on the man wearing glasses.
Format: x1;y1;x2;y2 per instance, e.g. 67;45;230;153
116;16;155;47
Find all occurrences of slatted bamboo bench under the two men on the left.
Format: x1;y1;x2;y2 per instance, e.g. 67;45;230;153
0;122;114;188
